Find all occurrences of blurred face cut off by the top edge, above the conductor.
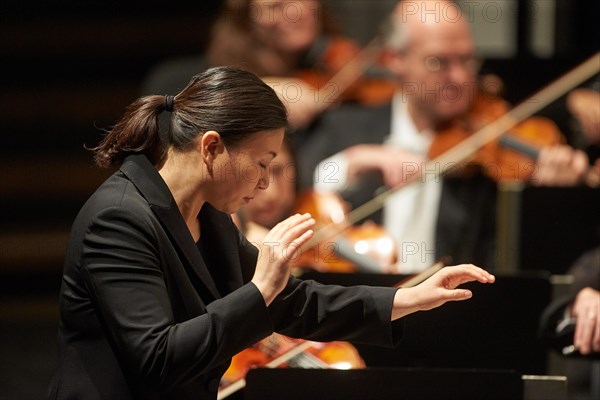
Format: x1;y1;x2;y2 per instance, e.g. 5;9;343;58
250;0;322;53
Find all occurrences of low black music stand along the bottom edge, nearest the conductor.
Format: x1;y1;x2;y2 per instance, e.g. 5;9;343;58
244;368;523;400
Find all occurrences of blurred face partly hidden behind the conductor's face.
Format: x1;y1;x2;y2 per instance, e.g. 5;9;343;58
243;146;296;228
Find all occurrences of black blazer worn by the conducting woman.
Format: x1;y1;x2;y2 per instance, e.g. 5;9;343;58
50;155;401;400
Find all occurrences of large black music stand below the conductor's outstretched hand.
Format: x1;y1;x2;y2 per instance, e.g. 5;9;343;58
302;271;552;375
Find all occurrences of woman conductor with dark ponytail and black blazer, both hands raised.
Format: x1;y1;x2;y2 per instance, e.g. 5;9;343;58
50;67;494;400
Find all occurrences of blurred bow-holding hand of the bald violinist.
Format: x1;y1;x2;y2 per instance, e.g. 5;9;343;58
343;144;426;188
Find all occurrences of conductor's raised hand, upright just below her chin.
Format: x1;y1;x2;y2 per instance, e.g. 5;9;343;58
252;213;315;306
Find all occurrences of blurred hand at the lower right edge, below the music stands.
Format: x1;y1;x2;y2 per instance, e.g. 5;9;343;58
571;287;600;354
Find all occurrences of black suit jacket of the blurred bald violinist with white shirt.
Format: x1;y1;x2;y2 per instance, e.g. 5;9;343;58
297;103;497;270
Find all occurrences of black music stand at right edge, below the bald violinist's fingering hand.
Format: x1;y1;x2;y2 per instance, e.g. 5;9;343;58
498;185;600;274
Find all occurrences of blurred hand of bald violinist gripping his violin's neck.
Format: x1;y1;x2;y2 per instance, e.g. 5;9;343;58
531;145;589;186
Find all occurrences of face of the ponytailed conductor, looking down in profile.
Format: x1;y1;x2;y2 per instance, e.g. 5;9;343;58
207;128;284;214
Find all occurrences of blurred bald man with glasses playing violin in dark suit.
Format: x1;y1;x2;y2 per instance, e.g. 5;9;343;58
299;1;587;273
